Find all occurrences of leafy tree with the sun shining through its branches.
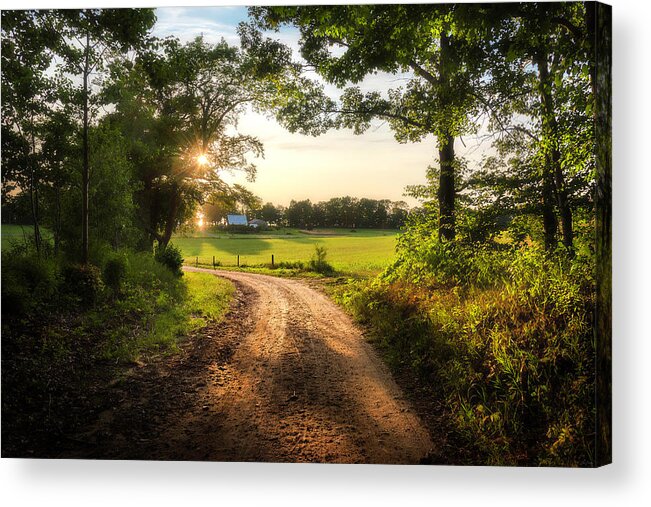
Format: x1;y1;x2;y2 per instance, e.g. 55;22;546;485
107;37;310;247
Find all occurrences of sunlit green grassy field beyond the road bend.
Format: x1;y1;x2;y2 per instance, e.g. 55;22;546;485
172;229;397;275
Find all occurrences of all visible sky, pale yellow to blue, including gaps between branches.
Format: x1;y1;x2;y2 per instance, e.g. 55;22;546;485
153;6;492;206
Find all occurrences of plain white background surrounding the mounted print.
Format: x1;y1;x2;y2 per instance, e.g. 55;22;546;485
0;0;651;507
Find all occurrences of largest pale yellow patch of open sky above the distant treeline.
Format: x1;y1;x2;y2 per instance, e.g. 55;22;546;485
225;112;435;205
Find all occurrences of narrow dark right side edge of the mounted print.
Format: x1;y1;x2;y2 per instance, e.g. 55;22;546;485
586;2;612;466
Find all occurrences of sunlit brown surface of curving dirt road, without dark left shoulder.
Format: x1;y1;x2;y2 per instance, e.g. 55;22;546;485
181;267;432;464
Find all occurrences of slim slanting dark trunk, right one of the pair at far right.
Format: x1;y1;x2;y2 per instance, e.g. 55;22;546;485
535;50;574;251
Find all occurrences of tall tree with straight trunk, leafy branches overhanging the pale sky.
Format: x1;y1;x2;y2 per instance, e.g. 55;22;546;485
251;4;490;240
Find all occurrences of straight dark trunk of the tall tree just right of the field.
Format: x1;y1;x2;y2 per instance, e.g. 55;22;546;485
438;32;456;241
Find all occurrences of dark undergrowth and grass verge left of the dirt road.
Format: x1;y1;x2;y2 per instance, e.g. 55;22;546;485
2;244;234;455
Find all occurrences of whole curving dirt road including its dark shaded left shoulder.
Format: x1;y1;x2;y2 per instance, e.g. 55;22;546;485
65;268;432;463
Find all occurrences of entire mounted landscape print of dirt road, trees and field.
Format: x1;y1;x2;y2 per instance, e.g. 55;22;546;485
2;2;612;467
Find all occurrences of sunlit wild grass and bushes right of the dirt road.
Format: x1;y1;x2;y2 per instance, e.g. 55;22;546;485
340;245;594;466
